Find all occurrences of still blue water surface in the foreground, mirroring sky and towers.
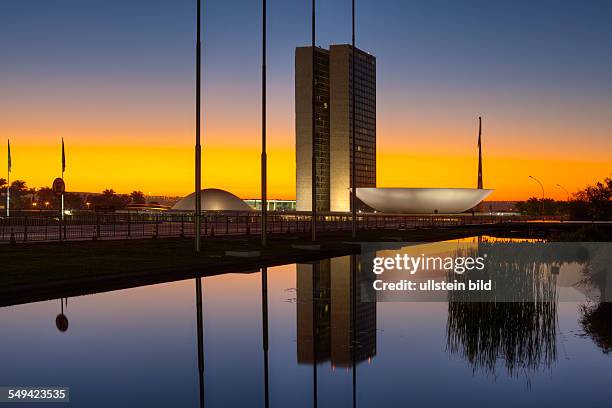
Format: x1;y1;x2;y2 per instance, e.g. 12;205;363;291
0;239;612;407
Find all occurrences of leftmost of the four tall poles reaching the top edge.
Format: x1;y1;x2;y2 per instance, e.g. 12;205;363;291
194;0;202;252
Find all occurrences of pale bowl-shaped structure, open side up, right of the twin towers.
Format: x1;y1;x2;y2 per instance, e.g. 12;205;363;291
357;188;493;214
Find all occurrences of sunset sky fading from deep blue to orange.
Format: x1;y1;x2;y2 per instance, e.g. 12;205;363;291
0;0;612;200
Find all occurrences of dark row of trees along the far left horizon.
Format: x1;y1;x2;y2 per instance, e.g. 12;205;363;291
0;178;146;210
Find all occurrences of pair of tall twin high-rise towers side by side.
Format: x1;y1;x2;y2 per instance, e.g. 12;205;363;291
295;45;376;212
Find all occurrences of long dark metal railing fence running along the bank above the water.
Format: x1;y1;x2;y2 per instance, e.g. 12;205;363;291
0;212;540;243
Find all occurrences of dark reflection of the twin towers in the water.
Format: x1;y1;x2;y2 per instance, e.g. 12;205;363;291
297;256;376;367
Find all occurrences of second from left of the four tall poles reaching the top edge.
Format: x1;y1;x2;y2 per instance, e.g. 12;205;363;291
261;0;268;246
